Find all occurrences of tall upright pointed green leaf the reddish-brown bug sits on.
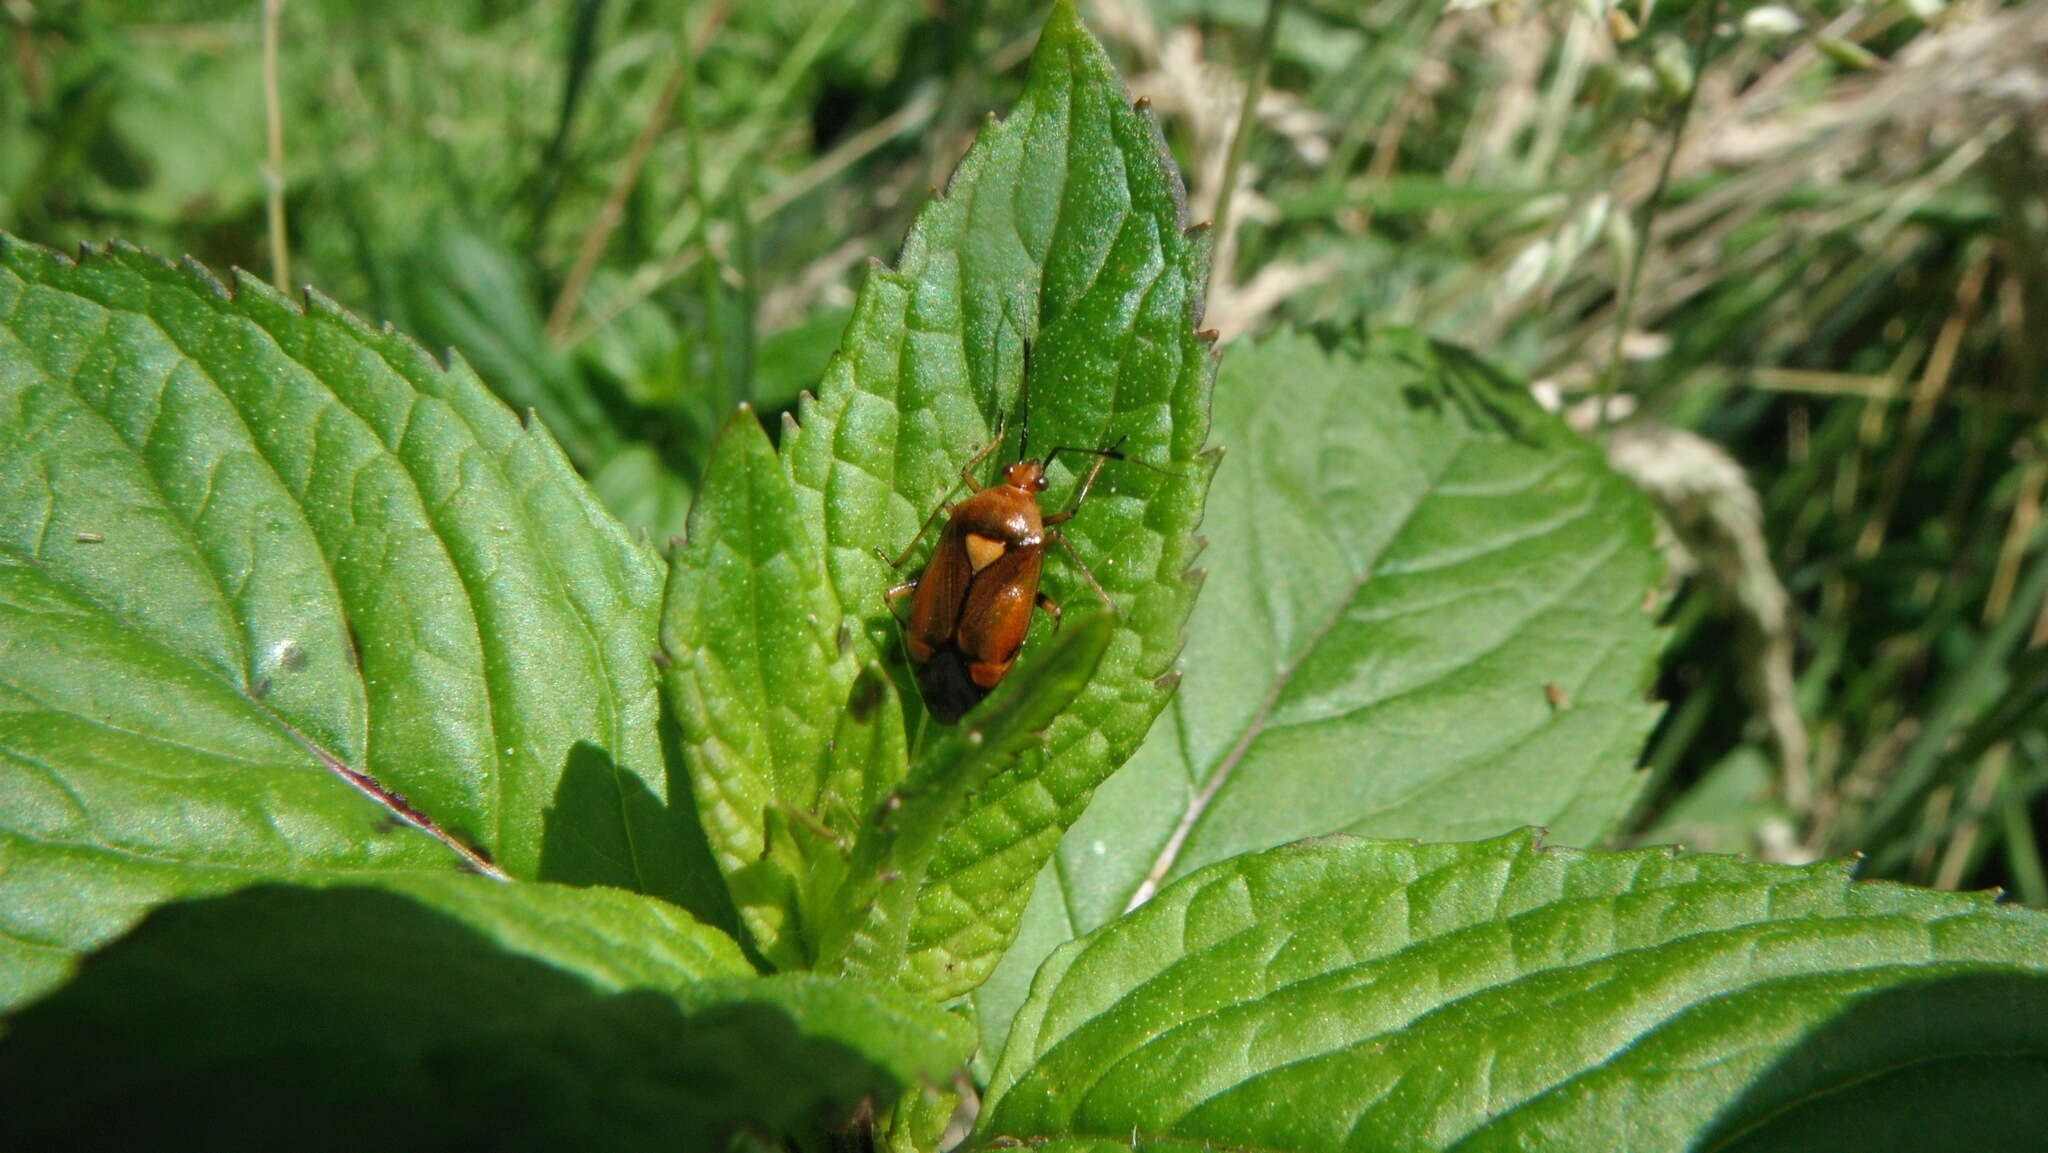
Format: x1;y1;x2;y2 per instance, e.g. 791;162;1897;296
782;2;1210;995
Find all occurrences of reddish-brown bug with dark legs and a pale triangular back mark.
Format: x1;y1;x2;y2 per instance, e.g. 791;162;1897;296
889;436;1120;725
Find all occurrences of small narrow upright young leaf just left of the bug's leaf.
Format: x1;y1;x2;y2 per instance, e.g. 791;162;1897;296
662;408;876;969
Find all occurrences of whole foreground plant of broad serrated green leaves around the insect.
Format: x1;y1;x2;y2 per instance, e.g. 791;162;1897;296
0;2;2048;1149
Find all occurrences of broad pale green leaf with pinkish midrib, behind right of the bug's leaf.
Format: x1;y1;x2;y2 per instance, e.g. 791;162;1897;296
981;323;1661;1049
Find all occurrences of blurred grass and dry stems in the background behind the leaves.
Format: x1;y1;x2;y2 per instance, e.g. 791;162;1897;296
0;0;2048;905
